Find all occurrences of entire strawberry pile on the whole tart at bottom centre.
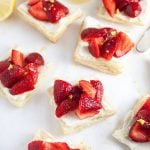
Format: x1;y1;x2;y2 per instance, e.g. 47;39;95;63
54;80;103;119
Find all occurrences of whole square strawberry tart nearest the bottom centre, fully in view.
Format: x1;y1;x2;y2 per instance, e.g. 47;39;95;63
49;80;116;134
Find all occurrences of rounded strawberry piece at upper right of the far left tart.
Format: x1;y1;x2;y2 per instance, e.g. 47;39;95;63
25;52;44;66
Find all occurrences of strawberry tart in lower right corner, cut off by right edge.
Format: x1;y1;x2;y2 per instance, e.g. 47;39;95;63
113;95;150;150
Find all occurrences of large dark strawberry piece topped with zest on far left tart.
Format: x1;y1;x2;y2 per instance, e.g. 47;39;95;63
0;65;24;88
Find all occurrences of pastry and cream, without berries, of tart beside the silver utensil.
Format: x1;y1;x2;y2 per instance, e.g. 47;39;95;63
74;16;134;75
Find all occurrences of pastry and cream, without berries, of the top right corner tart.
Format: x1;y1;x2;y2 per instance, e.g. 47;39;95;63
98;0;150;24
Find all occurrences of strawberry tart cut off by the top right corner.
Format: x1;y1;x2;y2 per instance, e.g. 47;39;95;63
97;0;150;25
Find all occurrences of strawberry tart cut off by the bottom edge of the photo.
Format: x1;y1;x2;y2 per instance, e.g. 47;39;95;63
28;130;91;150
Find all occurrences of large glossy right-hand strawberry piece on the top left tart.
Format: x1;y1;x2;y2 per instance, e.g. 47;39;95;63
42;0;69;23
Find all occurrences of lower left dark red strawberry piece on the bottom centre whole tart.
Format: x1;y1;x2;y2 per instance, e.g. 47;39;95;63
56;98;79;117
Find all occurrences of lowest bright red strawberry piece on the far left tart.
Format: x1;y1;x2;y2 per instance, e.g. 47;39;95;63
10;74;35;95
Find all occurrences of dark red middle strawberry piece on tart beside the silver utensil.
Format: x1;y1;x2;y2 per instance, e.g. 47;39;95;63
100;37;117;60
